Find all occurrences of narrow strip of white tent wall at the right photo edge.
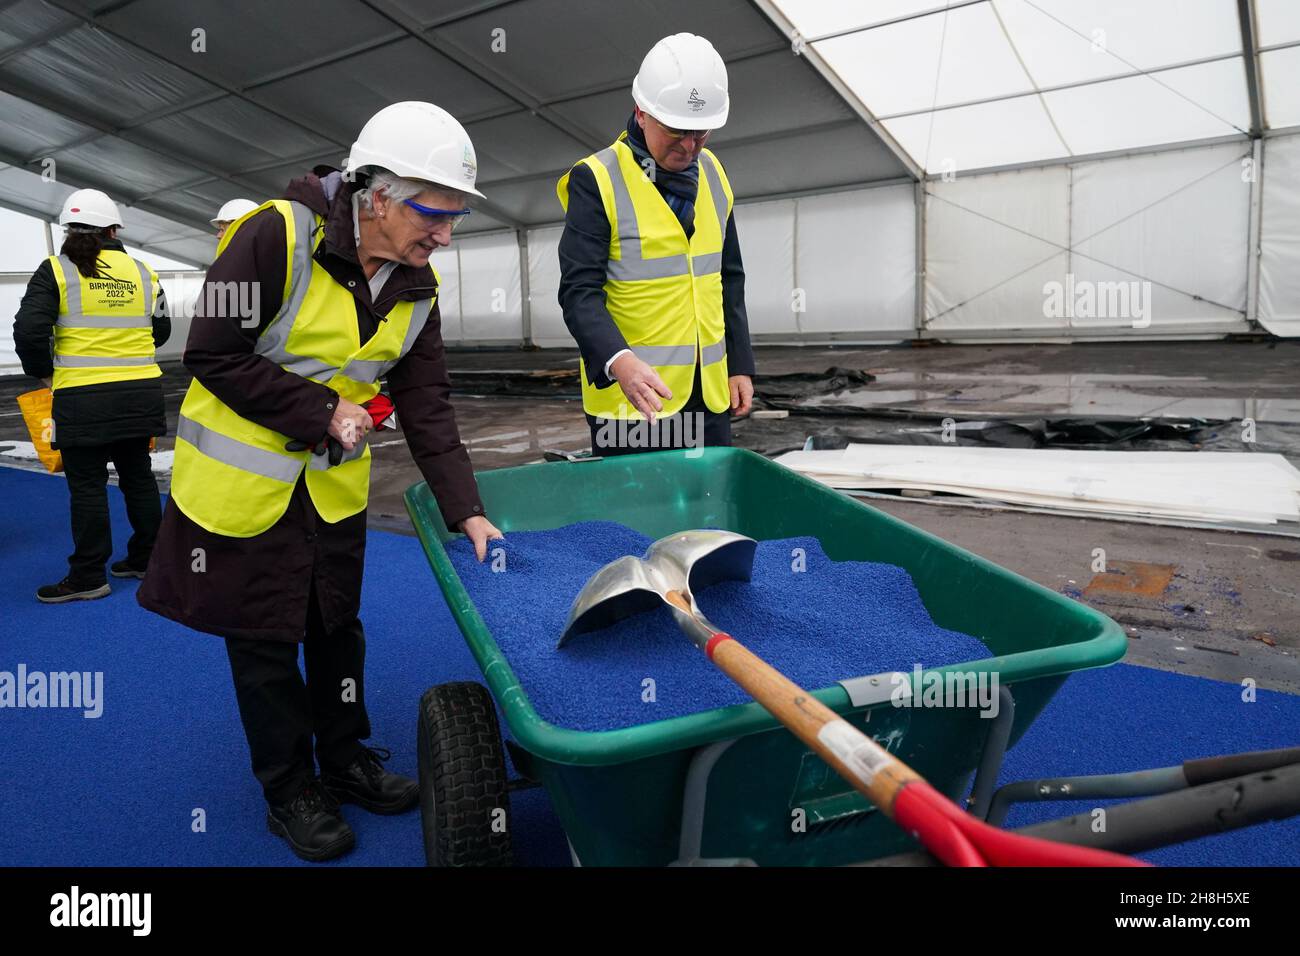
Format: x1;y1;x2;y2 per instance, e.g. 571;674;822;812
1258;128;1300;336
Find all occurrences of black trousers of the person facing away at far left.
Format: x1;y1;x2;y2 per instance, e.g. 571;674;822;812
60;437;163;587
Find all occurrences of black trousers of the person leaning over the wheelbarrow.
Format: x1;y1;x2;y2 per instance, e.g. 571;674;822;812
226;591;371;804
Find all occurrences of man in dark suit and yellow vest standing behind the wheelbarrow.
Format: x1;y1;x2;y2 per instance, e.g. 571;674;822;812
556;34;754;455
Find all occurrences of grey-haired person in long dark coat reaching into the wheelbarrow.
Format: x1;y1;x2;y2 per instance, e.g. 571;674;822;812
139;103;501;860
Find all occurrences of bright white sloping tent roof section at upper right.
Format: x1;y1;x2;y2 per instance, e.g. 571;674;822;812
757;0;1300;173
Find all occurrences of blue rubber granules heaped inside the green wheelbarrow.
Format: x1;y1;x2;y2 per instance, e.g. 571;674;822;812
447;522;991;731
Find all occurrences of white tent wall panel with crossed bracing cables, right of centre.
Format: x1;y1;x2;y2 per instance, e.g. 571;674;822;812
924;140;1253;341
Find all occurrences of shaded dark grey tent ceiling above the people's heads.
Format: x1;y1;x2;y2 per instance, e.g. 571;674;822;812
0;0;909;261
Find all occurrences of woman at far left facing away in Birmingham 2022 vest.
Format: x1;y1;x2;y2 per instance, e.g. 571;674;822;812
13;189;172;604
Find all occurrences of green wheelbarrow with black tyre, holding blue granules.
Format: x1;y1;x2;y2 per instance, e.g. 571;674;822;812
406;447;1127;866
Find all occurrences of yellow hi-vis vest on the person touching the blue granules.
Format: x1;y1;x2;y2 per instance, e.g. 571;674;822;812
172;199;437;537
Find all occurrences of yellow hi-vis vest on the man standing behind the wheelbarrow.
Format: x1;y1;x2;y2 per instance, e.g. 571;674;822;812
555;133;735;419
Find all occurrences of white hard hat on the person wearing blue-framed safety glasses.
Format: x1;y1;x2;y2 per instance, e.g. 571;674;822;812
343;100;484;198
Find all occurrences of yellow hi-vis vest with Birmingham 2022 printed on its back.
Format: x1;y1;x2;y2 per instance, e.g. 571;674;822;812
49;248;163;390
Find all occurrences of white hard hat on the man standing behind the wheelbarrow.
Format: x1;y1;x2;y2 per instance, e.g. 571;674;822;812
632;34;731;130
